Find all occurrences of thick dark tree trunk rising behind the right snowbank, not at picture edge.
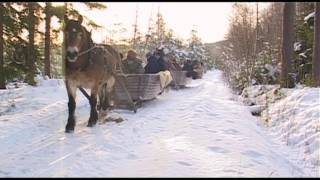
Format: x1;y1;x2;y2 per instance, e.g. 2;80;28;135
280;2;296;88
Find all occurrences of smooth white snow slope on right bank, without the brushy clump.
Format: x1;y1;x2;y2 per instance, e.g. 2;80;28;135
265;87;320;173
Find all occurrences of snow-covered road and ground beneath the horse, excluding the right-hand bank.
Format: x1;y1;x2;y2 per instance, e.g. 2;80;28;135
0;71;319;177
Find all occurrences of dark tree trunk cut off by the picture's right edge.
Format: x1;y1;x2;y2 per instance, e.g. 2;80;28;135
312;2;320;86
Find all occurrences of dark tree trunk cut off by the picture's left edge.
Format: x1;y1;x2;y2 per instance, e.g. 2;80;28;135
0;3;6;89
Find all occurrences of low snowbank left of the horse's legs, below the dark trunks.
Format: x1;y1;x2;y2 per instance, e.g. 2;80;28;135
0;76;88;129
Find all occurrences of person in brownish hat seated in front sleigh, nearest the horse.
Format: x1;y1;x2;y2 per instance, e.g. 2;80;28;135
122;50;144;74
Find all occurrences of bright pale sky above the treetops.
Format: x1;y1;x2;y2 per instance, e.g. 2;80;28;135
70;2;266;43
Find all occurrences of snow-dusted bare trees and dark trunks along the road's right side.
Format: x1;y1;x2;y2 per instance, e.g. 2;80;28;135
210;2;320;93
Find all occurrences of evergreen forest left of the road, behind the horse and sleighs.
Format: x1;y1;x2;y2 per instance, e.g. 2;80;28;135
0;2;213;89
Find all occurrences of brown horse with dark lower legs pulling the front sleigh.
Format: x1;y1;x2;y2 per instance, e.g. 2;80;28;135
64;16;121;132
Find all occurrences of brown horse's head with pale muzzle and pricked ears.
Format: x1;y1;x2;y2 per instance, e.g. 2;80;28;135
64;16;92;63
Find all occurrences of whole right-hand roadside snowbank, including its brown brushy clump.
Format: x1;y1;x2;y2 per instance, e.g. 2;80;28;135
242;85;320;174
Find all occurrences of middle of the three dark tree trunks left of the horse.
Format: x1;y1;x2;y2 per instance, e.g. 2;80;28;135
27;2;36;86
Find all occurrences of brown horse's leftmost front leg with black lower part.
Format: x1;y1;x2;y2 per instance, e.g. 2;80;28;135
65;80;77;133
